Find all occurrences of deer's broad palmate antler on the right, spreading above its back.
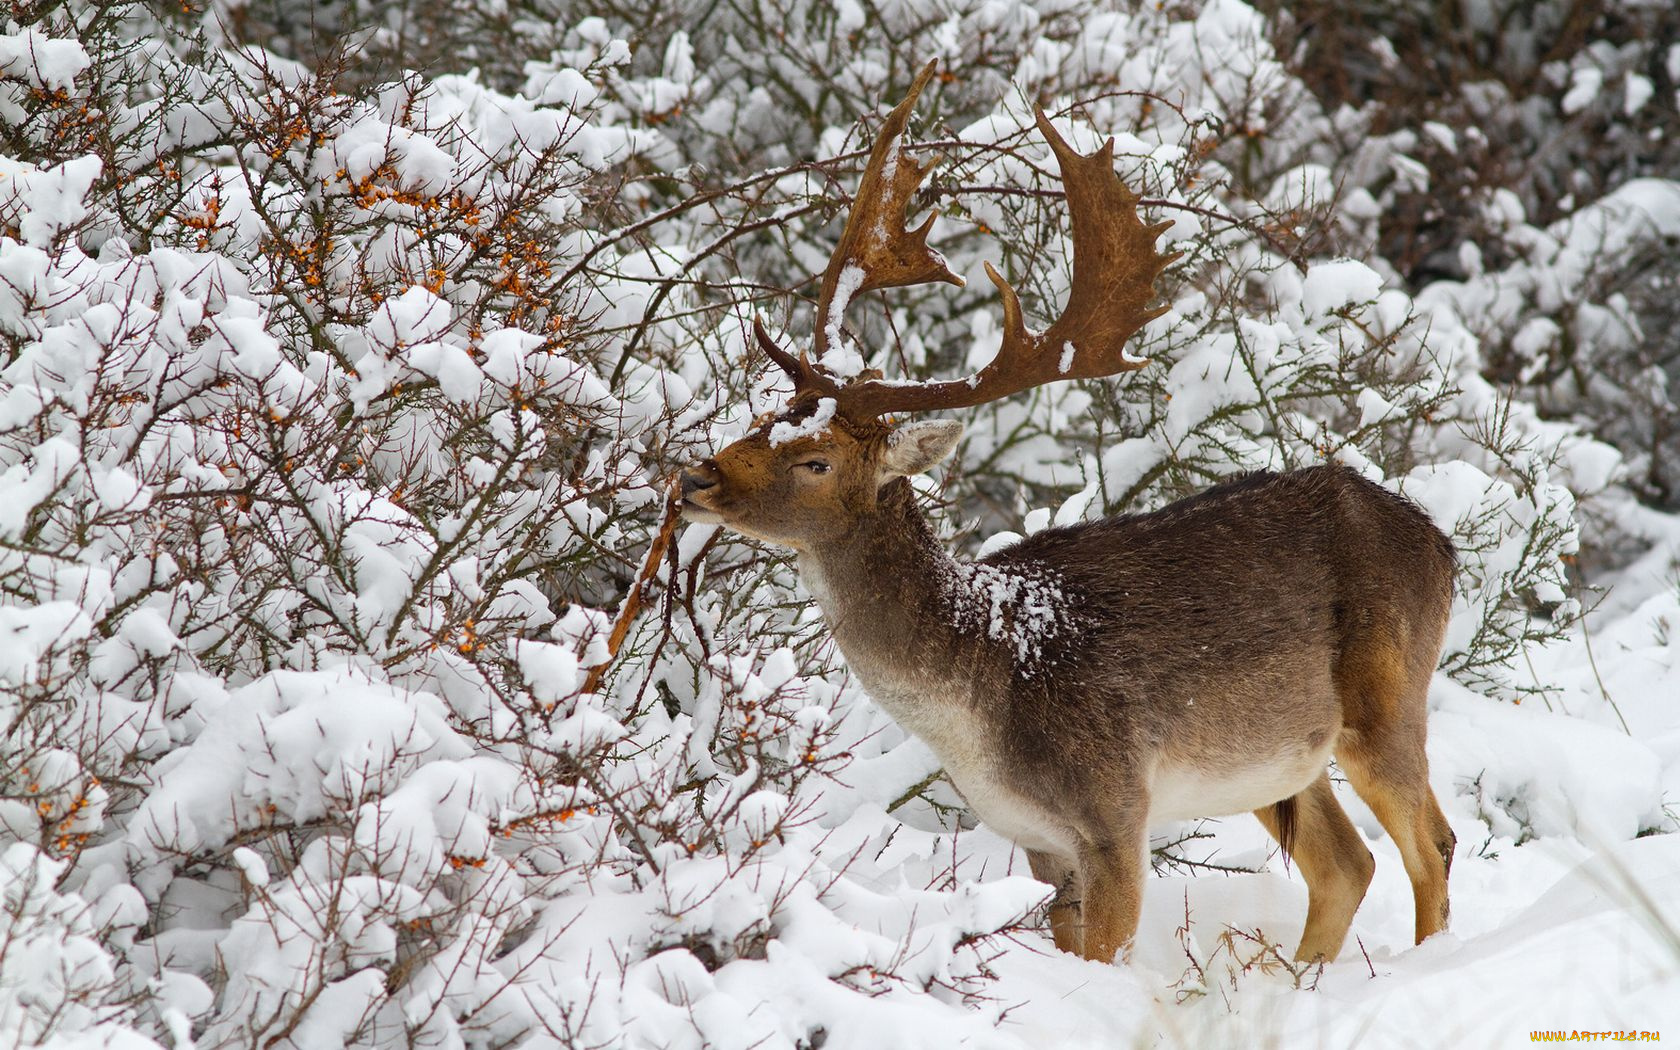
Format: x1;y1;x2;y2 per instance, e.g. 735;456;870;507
840;109;1179;420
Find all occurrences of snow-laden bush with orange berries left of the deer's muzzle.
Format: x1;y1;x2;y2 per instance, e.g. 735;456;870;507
0;8;1042;1047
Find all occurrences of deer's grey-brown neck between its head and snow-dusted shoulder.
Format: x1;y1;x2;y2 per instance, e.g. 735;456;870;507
798;479;1008;719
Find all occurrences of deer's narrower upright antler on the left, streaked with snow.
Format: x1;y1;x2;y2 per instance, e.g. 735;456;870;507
813;59;963;367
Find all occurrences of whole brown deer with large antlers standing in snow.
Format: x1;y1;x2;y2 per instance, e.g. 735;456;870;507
674;62;1455;963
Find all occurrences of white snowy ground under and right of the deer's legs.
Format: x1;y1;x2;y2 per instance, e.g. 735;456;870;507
981;789;1680;1047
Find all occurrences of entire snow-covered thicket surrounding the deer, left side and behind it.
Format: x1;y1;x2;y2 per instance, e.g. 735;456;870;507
0;0;1672;1048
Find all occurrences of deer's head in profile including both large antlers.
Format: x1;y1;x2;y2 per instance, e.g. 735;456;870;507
682;62;1178;549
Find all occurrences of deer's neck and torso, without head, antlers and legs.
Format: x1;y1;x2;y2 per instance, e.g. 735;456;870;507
779;467;1453;958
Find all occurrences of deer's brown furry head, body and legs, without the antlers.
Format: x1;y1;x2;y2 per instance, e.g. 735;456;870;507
684;414;1453;959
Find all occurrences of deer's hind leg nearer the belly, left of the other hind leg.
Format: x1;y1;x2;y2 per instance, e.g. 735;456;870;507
1255;773;1376;963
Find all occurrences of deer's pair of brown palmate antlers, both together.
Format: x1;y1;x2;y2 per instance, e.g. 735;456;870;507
753;62;1178;423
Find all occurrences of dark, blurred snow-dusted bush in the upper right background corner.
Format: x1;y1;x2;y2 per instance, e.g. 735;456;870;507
1258;0;1680;510
